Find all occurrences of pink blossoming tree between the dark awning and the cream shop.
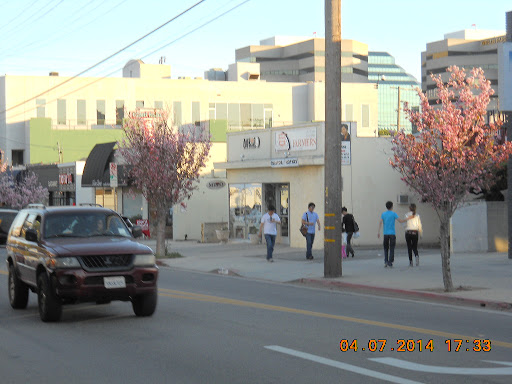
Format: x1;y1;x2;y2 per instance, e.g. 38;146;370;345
120;111;211;256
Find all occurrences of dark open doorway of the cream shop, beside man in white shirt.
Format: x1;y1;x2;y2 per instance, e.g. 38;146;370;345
263;184;290;244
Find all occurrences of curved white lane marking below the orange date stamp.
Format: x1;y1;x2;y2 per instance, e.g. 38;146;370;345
368;357;512;376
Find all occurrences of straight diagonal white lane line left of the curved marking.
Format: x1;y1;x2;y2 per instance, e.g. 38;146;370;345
265;345;421;384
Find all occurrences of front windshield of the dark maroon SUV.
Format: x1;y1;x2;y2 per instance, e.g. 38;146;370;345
42;212;131;239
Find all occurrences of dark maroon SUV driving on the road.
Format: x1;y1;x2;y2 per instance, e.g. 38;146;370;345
6;205;158;322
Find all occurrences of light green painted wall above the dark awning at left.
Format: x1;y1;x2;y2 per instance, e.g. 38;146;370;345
30;118;123;164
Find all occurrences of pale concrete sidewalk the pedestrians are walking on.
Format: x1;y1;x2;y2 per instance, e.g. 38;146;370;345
140;240;512;309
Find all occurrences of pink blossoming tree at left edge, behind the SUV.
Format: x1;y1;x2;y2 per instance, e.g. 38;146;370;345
0;171;48;209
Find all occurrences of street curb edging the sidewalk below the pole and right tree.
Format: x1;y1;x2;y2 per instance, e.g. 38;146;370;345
293;278;512;311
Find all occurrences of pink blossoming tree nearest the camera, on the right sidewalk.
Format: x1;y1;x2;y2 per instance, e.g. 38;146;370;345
390;66;512;291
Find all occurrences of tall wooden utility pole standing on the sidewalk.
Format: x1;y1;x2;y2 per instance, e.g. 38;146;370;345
324;0;342;278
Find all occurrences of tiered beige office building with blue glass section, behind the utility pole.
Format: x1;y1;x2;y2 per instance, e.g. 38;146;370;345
230;36;420;135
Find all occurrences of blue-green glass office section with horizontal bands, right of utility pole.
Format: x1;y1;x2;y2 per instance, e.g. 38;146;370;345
368;51;420;134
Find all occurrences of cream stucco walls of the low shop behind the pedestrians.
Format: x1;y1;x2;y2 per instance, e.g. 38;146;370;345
215;123;439;249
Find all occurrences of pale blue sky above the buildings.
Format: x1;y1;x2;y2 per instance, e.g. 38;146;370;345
0;0;512;80
